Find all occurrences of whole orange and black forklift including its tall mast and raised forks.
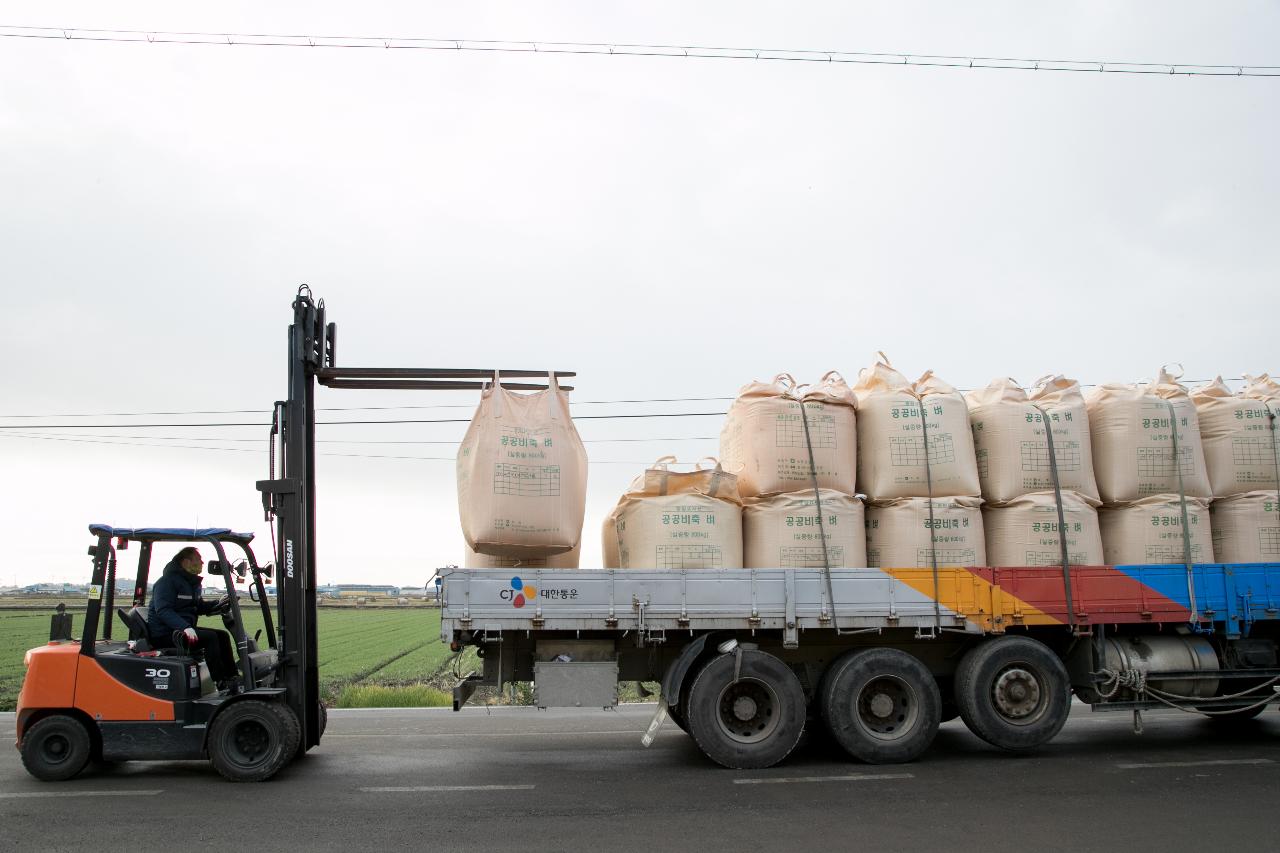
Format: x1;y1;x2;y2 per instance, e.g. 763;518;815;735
17;284;576;781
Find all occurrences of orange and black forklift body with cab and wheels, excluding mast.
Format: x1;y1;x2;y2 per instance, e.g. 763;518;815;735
17;524;307;781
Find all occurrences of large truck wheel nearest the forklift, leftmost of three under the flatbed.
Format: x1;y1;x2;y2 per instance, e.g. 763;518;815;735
681;649;805;770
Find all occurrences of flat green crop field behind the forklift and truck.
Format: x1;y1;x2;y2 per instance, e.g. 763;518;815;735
0;599;460;711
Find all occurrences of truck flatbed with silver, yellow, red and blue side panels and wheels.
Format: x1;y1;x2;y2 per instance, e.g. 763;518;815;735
440;564;1280;767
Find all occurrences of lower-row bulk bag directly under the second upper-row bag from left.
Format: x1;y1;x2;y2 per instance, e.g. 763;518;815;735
867;497;987;569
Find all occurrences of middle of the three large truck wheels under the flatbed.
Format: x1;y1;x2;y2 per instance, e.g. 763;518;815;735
822;648;942;765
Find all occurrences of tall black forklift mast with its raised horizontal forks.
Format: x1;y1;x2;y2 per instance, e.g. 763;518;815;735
257;284;577;749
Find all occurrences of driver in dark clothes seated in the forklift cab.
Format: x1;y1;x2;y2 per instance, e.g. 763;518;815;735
147;547;237;690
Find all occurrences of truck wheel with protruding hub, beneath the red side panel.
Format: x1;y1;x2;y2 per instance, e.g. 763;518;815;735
956;637;1071;751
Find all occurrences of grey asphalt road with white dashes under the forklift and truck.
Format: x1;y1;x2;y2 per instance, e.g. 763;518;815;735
0;704;1280;853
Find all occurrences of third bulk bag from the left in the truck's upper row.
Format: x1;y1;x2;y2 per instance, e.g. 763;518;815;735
965;377;1098;502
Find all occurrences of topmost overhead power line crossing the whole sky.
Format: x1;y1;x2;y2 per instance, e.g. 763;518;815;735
0;24;1280;77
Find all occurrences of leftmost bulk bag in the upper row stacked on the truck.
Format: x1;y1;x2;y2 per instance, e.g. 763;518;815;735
721;370;858;497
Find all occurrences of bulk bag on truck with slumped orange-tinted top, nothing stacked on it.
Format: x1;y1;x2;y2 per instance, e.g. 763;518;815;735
612;456;742;569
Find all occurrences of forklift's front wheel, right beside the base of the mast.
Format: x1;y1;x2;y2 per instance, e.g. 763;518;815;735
209;699;300;781
